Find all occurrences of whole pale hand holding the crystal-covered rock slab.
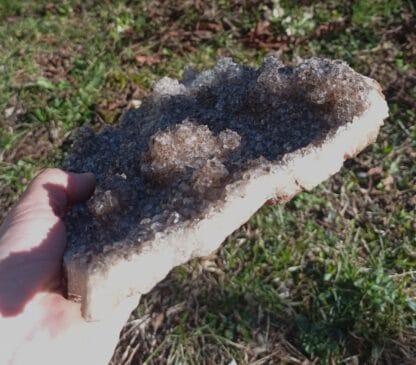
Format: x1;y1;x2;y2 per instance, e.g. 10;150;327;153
0;169;137;365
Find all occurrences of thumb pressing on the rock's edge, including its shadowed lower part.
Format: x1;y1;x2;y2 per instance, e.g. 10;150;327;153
0;169;95;316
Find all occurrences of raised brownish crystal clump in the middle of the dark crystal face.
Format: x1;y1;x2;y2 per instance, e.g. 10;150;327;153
141;120;241;192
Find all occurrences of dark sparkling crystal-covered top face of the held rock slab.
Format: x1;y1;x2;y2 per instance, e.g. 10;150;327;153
64;57;368;262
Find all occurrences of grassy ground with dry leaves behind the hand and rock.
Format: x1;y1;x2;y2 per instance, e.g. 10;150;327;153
0;0;416;364
